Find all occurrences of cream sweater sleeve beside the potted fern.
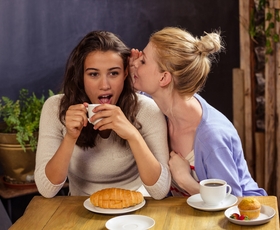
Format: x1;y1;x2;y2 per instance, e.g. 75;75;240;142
34;95;66;198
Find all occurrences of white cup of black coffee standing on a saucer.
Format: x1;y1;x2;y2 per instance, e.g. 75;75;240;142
199;179;232;205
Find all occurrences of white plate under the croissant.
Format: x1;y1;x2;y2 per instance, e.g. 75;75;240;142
84;198;146;214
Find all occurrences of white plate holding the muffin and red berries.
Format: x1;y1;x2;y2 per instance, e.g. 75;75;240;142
225;205;275;225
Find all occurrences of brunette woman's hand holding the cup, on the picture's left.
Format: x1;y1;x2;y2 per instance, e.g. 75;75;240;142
65;103;88;139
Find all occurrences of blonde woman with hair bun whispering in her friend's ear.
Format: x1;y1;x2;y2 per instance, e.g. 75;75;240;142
130;27;267;196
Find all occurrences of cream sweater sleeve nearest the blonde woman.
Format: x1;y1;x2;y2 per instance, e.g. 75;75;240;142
137;95;171;199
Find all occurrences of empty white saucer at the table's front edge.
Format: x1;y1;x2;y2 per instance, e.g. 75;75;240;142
105;215;155;230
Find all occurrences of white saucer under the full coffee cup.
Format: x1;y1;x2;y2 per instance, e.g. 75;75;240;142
187;194;238;211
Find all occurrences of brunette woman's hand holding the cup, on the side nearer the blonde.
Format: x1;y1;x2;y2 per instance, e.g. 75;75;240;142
90;104;137;141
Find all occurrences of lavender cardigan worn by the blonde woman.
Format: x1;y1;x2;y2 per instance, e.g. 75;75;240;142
194;94;267;196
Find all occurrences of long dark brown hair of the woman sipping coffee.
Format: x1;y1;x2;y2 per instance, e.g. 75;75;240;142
59;31;141;148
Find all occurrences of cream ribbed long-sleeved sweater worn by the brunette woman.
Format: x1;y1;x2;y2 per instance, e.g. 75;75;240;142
35;94;171;199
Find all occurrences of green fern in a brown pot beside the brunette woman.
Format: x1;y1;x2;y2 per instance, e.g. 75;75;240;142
0;89;53;184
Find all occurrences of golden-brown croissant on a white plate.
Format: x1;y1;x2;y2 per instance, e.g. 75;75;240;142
90;188;144;209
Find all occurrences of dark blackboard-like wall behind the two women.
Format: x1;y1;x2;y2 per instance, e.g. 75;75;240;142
0;0;239;120
